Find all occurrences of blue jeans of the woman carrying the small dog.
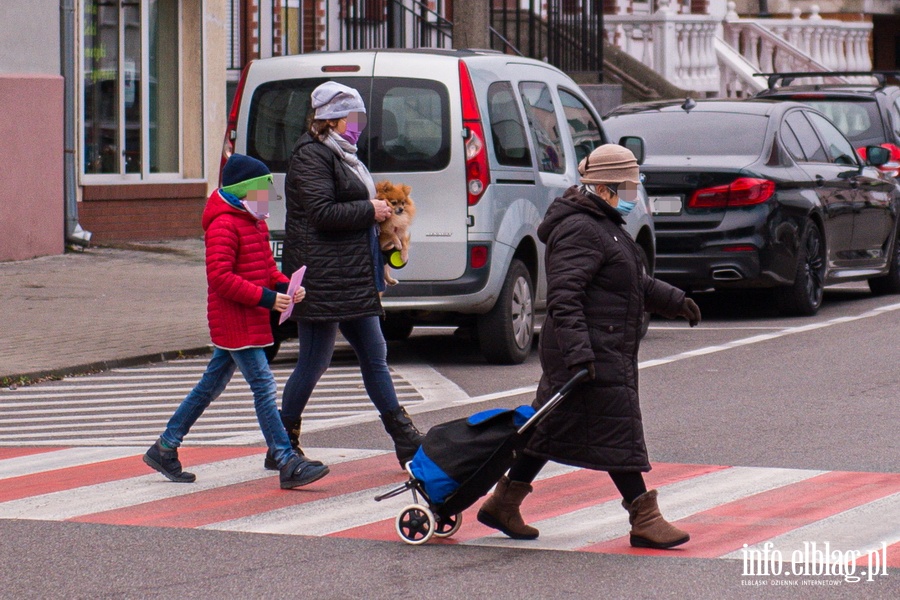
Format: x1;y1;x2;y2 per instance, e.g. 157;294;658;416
281;316;400;419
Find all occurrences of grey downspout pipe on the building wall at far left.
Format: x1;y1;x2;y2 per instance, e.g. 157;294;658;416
59;0;91;248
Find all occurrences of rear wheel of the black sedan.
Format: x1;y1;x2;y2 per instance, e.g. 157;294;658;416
775;223;825;316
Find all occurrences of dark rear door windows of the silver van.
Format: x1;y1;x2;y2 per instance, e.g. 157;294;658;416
247;77;450;173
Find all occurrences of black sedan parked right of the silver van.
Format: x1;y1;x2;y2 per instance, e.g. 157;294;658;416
603;99;900;315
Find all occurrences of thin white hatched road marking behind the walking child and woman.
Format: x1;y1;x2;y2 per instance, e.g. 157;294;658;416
0;346;424;445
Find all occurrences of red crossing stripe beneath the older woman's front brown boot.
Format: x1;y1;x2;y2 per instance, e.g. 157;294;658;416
580;471;900;558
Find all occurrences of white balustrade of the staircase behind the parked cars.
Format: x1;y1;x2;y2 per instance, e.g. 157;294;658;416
603;0;872;97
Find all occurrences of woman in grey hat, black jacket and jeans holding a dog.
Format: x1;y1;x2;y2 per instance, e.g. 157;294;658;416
266;81;422;474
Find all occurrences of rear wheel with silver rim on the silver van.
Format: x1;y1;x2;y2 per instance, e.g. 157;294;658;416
478;259;534;365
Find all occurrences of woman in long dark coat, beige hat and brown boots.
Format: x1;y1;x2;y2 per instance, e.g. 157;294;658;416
478;144;700;548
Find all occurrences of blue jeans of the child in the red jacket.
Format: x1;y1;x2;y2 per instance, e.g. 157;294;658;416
160;348;293;466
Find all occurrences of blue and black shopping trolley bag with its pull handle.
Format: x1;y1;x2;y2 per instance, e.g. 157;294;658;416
409;369;588;519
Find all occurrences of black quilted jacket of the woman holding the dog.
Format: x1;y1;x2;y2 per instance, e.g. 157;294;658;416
282;133;384;322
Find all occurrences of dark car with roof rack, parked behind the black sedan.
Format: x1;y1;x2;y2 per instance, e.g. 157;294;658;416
757;71;900;177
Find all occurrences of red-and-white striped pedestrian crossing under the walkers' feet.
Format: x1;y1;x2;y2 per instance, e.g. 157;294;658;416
0;446;900;568
